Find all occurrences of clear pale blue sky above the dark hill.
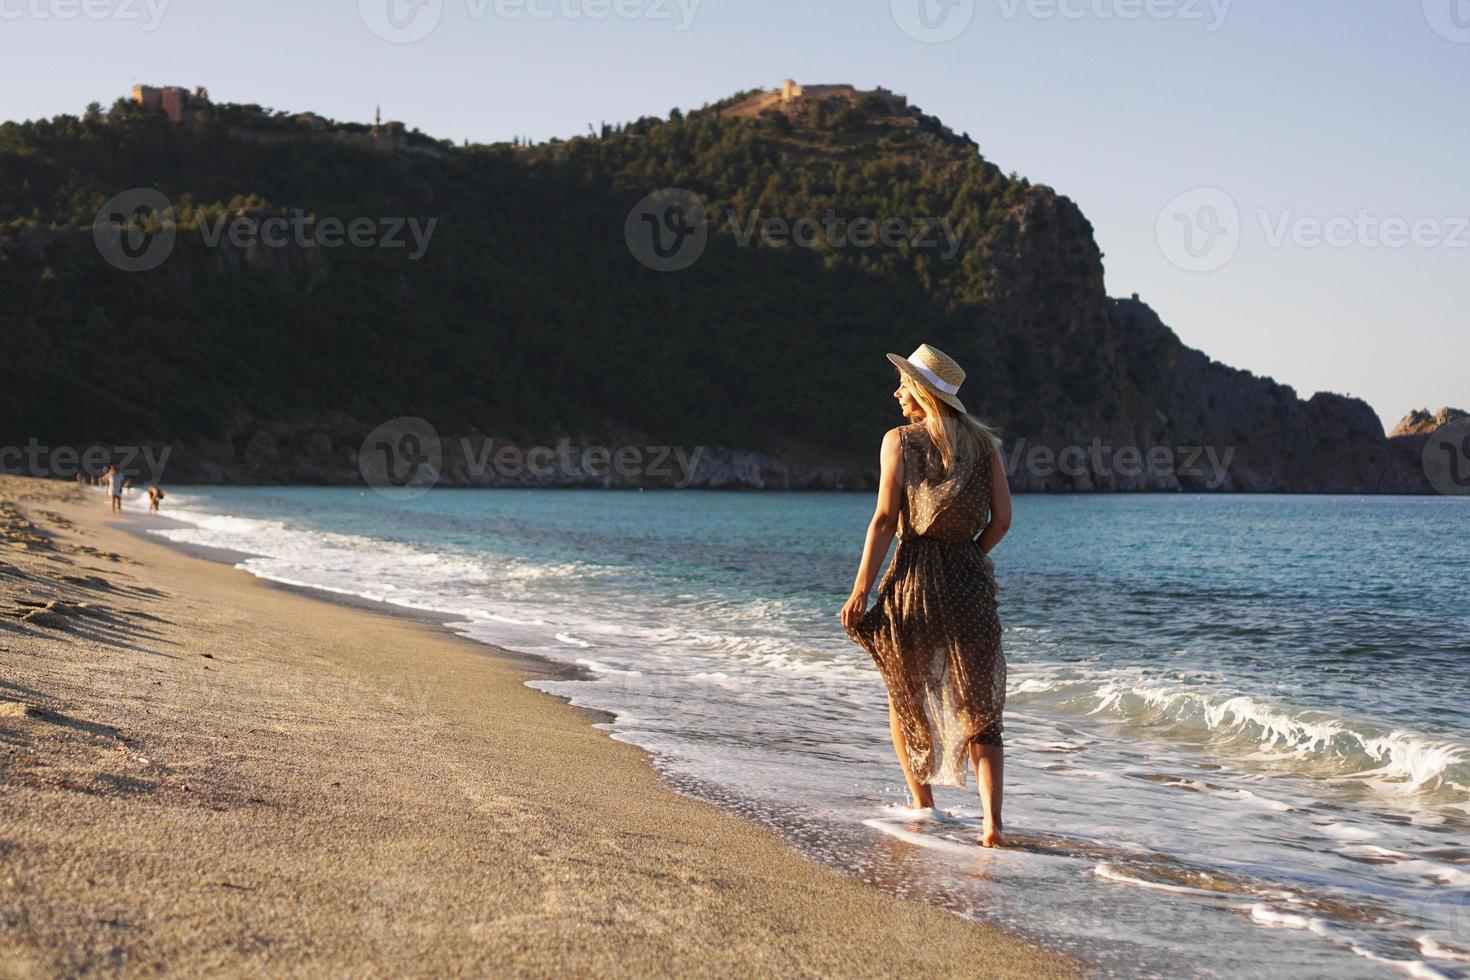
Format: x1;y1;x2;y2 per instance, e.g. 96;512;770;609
0;0;1470;426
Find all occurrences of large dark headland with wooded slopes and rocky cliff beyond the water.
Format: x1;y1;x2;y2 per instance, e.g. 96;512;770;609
0;86;1421;489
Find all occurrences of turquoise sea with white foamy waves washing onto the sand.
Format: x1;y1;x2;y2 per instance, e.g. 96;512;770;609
140;488;1470;977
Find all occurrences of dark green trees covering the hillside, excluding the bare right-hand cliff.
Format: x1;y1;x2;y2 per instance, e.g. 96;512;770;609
0;89;1081;453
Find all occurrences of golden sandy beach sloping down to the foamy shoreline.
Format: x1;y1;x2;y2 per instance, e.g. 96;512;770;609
0;478;1080;977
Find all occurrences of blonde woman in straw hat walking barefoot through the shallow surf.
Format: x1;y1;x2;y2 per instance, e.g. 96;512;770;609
839;344;1011;848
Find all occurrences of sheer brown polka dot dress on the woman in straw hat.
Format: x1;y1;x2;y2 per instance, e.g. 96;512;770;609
847;423;1005;786
